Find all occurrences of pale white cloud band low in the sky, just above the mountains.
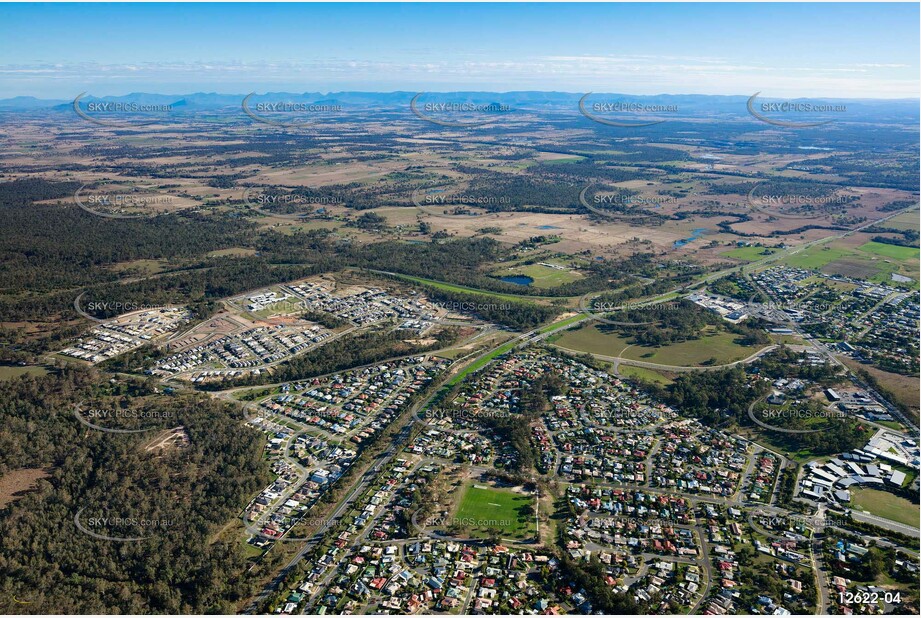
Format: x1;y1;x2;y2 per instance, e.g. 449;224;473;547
0;55;919;98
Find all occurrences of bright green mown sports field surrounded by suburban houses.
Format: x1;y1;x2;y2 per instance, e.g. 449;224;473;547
454;484;535;539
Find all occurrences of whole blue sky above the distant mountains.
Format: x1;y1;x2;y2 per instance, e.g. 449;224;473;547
0;3;921;99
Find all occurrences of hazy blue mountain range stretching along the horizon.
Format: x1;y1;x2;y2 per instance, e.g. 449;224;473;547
0;91;919;122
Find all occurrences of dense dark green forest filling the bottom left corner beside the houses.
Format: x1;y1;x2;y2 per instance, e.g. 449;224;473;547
0;369;270;614
